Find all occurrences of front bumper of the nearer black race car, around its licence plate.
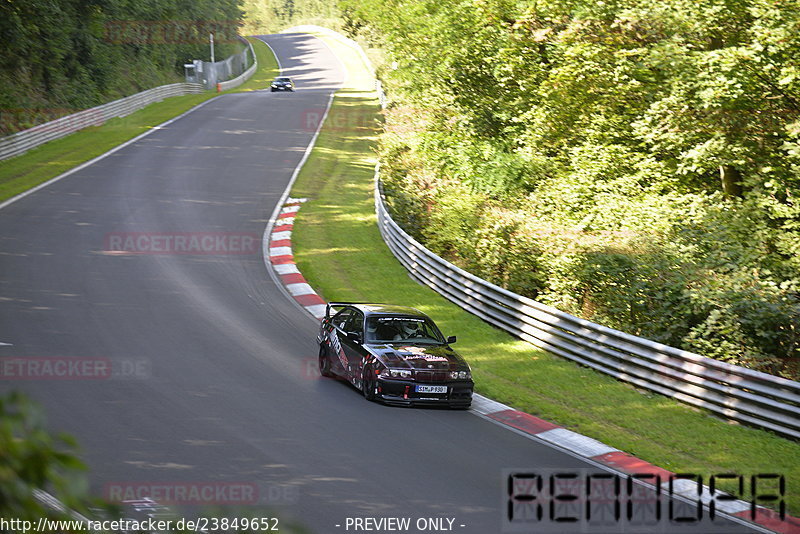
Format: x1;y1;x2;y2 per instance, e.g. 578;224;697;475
376;378;475;408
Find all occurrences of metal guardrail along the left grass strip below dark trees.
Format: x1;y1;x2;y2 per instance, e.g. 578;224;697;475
0;83;205;160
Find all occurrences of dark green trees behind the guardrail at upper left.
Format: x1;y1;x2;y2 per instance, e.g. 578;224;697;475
0;0;244;135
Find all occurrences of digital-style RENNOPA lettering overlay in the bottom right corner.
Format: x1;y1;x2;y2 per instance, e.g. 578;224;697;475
502;468;787;533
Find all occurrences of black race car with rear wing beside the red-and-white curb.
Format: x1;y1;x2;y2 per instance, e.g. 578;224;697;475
317;302;474;409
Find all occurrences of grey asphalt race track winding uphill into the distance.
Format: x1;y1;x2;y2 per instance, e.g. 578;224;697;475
0;34;750;534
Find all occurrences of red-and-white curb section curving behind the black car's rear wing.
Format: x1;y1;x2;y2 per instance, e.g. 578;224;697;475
269;198;326;319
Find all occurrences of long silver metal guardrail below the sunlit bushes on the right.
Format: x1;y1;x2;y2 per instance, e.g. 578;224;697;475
375;172;800;439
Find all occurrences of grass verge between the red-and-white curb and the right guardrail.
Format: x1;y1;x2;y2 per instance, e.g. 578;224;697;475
292;30;800;515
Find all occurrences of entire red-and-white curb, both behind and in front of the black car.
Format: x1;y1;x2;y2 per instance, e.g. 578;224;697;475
269;203;800;534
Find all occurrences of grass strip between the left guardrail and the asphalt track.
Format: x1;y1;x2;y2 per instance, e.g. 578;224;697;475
0;38;278;201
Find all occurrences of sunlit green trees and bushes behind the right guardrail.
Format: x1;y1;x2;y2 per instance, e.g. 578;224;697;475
339;0;800;379
